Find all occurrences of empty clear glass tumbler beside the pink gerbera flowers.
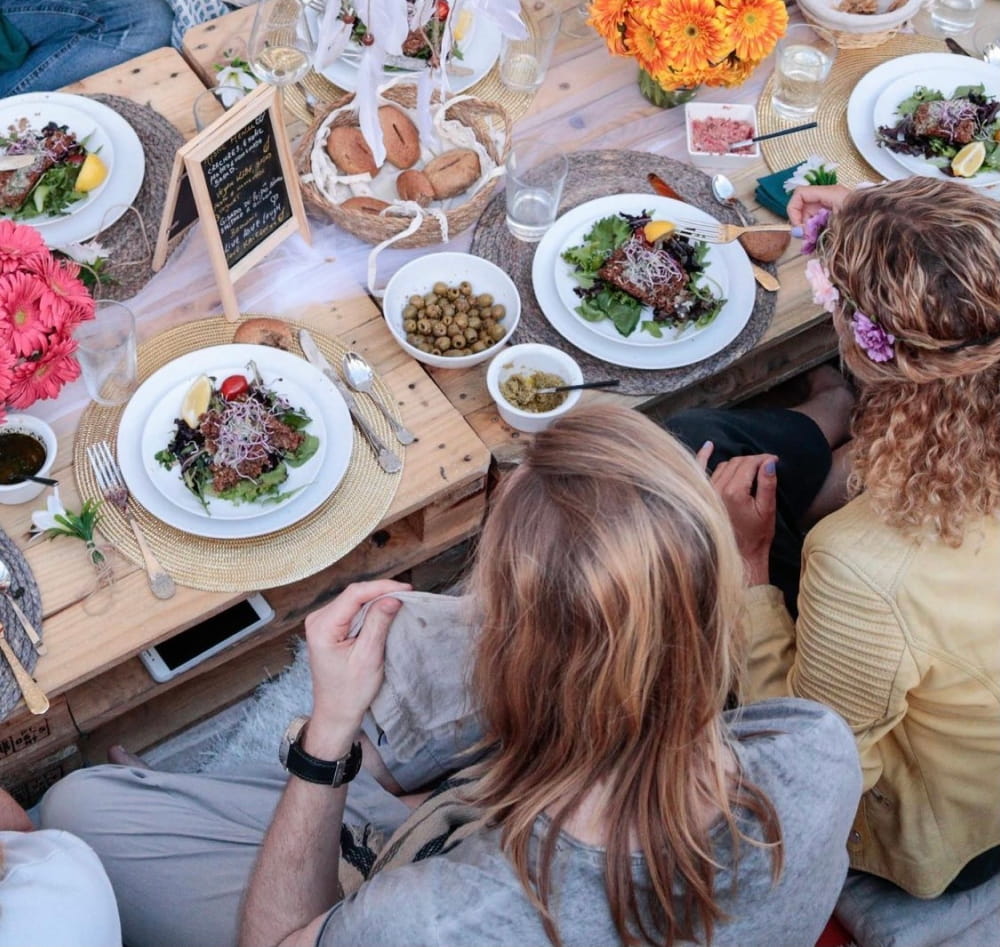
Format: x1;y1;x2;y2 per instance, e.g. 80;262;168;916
73;299;138;407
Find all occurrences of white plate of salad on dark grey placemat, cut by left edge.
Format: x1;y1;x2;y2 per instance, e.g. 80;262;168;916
0;92;146;247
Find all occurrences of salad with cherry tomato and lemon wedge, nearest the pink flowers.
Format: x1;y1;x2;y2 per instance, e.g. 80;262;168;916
155;362;319;512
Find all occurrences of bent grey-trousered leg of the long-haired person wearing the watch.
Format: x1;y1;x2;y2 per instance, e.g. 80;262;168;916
41;762;410;947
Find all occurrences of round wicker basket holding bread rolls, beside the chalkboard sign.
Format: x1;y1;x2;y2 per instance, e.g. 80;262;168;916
295;85;511;249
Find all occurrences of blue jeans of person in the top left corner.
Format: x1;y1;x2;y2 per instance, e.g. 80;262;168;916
0;0;174;96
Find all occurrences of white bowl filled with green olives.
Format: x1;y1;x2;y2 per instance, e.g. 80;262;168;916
382;253;521;368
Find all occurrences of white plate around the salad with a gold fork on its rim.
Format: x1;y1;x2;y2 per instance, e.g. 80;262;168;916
531;194;756;369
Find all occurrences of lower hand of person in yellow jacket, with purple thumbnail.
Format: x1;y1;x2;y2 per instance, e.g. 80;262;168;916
712;454;778;585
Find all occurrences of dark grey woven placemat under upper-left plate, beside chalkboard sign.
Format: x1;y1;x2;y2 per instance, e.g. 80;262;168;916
82;95;184;299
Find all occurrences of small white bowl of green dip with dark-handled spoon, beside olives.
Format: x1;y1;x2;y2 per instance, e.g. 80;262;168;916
486;342;583;434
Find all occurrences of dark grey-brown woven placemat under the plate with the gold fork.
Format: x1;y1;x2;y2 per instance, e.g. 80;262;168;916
472;151;775;395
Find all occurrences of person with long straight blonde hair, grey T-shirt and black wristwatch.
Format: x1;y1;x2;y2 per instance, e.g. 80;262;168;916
44;408;860;947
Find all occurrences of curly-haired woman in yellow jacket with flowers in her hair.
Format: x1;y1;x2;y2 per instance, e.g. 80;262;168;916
715;177;1000;898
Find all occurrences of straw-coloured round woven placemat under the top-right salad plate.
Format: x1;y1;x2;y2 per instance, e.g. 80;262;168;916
757;35;948;187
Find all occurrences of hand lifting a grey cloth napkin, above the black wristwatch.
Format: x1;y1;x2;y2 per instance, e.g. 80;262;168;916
306;579;410;759
